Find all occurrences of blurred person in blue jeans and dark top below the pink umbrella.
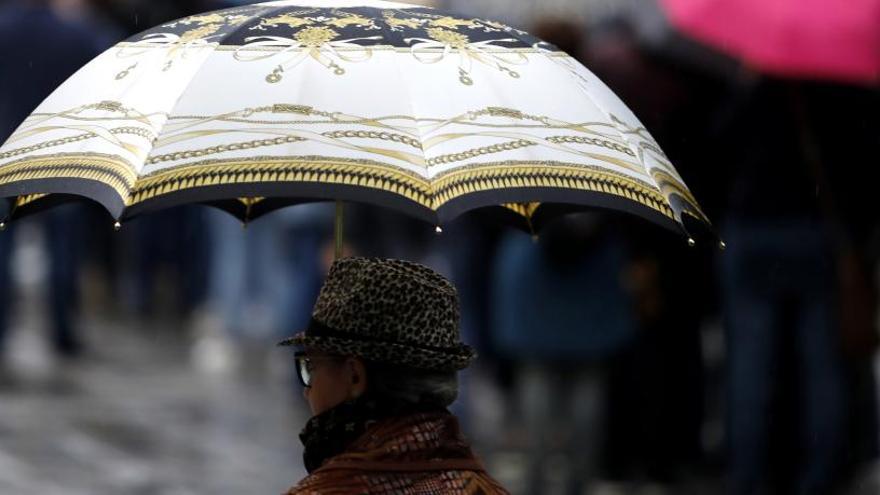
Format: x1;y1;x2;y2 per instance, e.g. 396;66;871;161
720;79;846;495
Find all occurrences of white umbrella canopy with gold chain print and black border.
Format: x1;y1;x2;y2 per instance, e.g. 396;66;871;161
0;0;708;240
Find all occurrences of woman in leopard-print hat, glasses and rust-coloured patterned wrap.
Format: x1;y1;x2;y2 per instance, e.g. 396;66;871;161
281;258;507;495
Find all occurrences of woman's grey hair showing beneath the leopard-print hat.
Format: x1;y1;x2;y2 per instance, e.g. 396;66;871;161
364;361;458;408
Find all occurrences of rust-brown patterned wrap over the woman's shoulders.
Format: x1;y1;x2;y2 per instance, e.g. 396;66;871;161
287;412;508;495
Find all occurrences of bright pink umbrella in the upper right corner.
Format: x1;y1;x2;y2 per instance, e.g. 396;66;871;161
661;0;880;85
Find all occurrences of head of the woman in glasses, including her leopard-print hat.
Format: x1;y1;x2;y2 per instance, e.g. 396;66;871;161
281;258;476;414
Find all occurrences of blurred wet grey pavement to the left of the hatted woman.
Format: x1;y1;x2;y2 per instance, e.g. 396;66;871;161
0;300;307;495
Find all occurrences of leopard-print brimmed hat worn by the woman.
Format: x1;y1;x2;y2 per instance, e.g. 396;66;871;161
278;257;476;371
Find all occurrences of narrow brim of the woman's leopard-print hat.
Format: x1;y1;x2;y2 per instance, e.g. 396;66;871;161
278;332;477;371
